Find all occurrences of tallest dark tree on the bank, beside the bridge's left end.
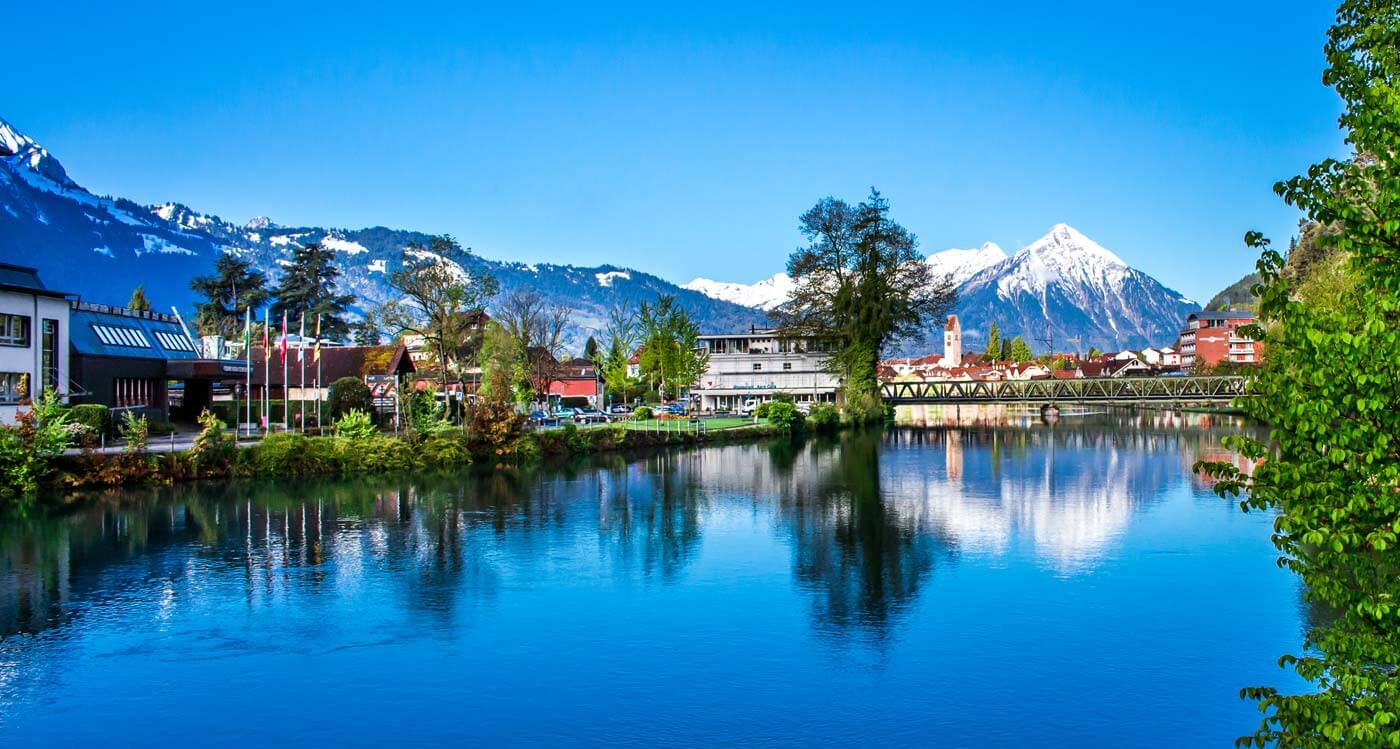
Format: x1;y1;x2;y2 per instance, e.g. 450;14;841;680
778;189;955;420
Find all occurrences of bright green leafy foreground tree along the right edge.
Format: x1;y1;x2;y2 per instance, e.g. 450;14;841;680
1200;0;1400;746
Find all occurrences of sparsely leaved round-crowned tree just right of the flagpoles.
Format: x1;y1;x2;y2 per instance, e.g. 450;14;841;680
378;237;498;386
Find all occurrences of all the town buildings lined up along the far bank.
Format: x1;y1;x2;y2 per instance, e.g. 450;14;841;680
0;256;1261;423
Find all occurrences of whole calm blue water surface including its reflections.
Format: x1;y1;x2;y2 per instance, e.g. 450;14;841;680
0;417;1306;748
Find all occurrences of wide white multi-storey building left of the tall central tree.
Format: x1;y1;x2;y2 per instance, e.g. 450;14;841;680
692;330;841;410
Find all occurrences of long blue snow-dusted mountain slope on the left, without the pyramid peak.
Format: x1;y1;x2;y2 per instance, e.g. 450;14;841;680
0;119;766;347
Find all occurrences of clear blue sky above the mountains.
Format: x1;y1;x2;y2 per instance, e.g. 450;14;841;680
8;0;1344;301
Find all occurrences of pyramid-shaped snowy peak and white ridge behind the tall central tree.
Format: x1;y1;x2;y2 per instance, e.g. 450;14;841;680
686;224;1200;351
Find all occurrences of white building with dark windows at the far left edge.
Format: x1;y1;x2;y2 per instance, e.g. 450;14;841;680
0;263;70;424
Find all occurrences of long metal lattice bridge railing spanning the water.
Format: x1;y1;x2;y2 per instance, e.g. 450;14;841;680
881;375;1246;403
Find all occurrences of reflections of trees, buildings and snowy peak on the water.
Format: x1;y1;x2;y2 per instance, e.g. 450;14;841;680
0;417;1260;637
